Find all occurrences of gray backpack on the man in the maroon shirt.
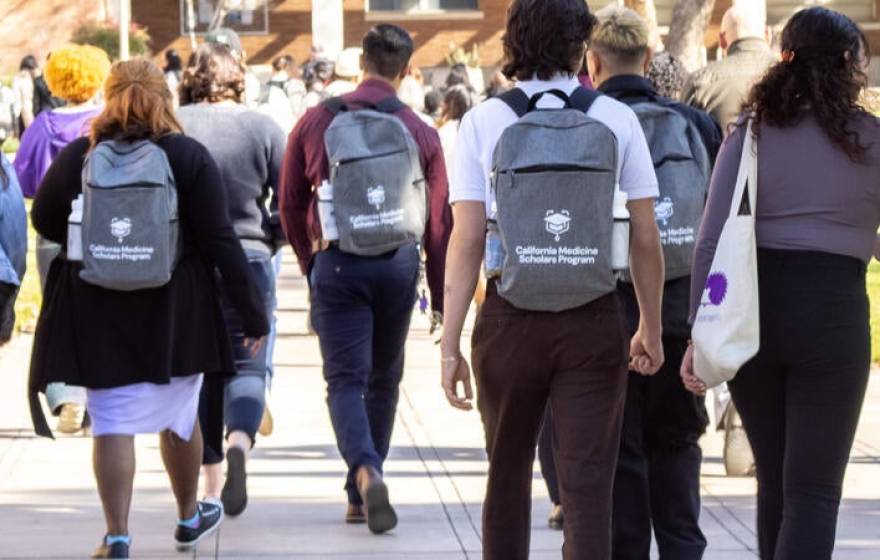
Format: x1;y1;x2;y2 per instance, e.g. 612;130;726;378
324;97;428;256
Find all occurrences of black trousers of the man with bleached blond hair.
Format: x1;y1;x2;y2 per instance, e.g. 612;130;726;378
613;337;709;560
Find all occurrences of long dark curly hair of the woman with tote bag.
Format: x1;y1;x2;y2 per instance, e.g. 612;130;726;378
745;7;870;162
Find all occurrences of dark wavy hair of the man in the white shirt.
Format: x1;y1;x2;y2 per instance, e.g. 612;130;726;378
501;0;596;80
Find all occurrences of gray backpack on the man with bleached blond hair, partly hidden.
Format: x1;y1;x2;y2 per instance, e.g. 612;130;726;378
627;102;710;280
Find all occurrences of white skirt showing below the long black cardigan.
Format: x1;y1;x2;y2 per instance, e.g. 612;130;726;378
86;373;203;441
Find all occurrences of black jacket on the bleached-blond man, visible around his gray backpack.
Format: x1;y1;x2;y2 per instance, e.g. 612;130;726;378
599;75;722;337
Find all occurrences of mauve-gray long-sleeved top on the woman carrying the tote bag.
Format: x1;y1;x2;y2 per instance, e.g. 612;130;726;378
691;115;880;321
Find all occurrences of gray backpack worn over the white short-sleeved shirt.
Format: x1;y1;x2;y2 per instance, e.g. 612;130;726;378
492;88;618;311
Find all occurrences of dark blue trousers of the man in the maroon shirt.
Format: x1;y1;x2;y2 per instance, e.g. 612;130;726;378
309;245;419;504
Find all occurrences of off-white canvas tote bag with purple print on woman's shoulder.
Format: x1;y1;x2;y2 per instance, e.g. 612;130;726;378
692;121;760;388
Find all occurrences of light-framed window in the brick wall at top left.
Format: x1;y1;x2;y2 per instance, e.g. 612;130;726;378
180;0;269;35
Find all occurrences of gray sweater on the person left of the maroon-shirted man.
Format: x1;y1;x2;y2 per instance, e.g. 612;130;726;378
177;103;286;253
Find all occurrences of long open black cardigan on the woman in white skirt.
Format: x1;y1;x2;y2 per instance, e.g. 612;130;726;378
29;134;269;435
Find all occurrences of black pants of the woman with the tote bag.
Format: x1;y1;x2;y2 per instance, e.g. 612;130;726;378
730;250;871;560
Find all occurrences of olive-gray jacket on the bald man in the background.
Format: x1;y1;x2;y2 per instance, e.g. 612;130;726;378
681;38;778;136
